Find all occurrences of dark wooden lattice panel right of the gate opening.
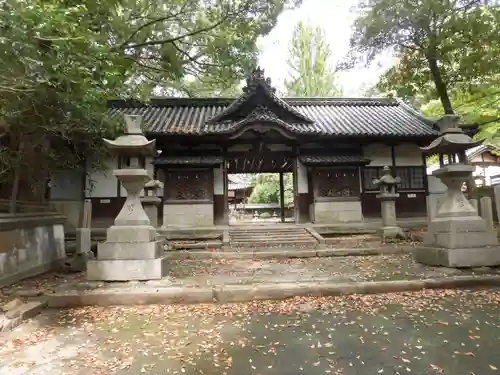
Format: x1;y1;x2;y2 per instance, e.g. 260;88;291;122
314;168;359;198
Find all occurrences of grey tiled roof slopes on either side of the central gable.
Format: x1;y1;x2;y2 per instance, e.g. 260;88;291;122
108;98;437;137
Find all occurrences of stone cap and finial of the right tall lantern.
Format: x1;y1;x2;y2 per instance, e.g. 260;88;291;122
420;115;481;154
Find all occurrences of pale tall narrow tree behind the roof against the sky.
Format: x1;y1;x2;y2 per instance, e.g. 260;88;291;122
285;22;342;97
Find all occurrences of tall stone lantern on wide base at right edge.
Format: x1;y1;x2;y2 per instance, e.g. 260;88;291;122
414;115;500;267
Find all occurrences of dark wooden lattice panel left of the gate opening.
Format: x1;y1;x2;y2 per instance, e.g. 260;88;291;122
164;169;213;201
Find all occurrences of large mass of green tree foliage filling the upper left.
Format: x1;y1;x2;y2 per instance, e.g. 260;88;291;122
0;0;298;203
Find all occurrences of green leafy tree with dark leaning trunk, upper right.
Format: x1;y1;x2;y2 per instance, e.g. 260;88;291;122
347;0;500;113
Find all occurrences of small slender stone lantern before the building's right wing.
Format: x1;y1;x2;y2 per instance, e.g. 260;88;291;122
373;166;405;239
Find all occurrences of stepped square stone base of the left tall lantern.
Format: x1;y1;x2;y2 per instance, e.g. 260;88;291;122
87;225;167;281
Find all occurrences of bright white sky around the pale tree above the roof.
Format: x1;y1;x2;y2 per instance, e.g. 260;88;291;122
259;0;393;96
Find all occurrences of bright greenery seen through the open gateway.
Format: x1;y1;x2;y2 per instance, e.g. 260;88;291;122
248;173;293;207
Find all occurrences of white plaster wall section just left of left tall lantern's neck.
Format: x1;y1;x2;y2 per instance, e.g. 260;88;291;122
85;158;118;198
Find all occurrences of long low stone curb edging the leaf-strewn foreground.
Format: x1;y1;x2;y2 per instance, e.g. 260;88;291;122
43;276;500;307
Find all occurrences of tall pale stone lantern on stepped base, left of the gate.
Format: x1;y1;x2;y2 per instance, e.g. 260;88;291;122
87;115;165;281
